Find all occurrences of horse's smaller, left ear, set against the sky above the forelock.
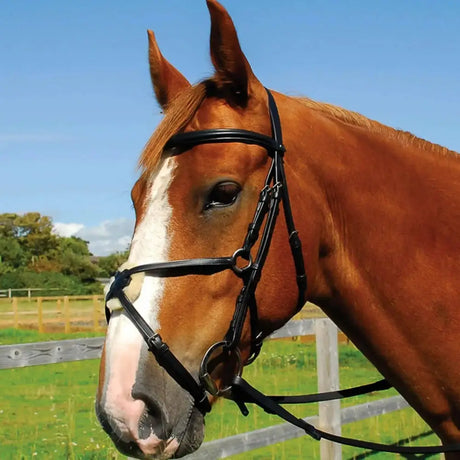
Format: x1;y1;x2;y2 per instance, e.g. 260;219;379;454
147;30;190;109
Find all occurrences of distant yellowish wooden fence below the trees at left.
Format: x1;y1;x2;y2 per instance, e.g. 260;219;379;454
0;295;105;333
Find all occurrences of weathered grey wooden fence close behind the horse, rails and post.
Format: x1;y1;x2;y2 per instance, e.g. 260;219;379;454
0;318;408;460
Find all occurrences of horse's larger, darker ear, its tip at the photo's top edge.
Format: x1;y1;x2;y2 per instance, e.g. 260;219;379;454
207;0;260;100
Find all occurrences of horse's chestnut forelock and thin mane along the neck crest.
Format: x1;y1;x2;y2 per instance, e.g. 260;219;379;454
139;80;459;174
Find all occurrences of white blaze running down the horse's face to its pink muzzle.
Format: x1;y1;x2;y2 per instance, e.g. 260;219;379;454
103;158;176;442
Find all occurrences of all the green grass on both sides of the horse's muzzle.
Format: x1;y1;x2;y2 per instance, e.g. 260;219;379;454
0;330;439;460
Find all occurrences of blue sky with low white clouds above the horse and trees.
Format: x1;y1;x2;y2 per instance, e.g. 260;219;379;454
0;0;460;255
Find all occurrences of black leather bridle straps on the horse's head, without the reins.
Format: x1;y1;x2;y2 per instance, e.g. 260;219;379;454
106;89;307;414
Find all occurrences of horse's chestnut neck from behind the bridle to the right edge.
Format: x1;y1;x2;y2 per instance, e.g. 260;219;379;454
283;94;460;438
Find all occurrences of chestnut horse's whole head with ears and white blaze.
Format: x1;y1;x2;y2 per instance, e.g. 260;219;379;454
96;0;314;458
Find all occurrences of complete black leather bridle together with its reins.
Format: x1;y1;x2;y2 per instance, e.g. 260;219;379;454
105;89;460;454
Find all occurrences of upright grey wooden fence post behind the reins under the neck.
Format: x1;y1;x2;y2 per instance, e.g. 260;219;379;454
315;318;342;460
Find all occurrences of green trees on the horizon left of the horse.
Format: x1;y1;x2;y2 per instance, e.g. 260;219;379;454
0;212;127;295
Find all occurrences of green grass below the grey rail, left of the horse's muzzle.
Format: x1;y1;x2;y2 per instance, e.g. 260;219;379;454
0;360;120;459
